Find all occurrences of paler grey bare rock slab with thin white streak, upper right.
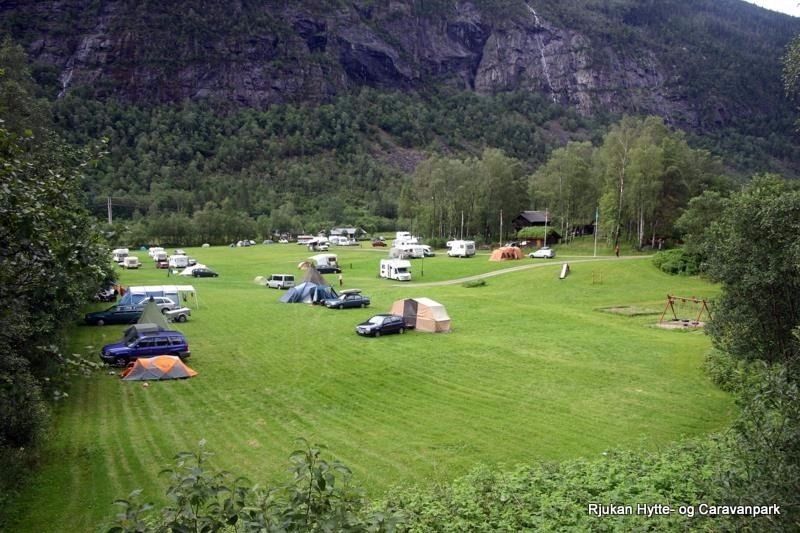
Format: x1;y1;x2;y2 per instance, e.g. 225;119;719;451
475;8;693;122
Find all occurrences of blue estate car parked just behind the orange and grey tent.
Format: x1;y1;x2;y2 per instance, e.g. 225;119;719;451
100;324;191;366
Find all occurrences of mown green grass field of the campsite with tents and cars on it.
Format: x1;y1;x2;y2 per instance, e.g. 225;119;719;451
7;245;734;532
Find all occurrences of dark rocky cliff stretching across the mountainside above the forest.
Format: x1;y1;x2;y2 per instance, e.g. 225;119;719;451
0;0;800;127
